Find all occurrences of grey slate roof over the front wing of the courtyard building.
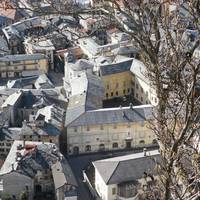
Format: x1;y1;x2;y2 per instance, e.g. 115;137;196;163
69;105;153;127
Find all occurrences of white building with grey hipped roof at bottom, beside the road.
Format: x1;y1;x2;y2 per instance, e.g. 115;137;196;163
93;150;160;200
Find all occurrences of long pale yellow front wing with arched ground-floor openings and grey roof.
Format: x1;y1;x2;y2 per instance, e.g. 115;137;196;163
62;105;156;154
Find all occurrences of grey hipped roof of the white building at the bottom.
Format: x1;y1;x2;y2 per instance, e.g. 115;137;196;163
93;150;161;185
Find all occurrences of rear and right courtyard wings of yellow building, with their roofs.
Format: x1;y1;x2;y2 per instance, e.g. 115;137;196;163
99;58;158;105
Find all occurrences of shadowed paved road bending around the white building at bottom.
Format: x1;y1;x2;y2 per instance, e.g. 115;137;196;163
68;147;157;200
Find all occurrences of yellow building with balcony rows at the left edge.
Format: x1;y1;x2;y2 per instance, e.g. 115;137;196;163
0;54;48;78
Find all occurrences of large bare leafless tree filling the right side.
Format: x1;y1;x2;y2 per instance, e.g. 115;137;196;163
0;0;200;200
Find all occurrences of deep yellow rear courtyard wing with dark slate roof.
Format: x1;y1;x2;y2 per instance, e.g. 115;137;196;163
100;58;133;99
